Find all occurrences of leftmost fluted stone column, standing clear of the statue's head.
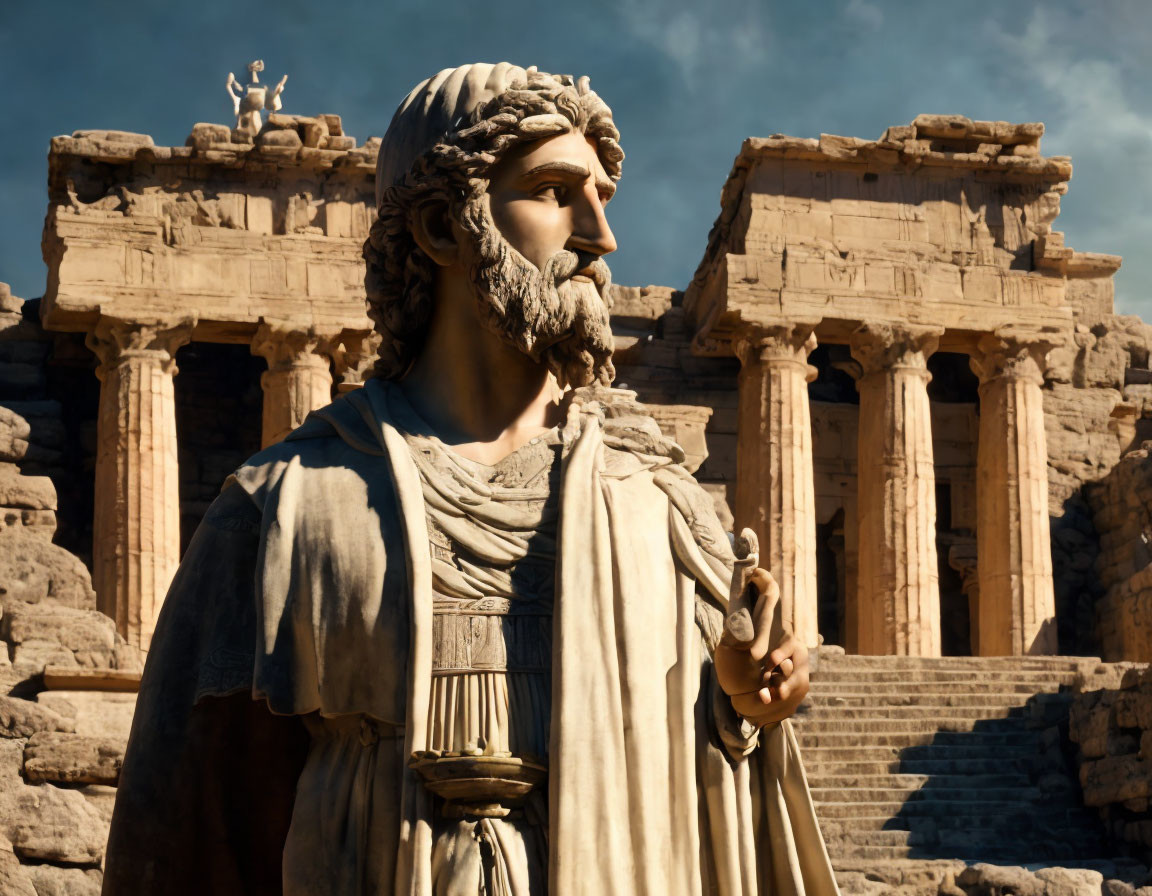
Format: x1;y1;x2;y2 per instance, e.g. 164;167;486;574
88;317;195;650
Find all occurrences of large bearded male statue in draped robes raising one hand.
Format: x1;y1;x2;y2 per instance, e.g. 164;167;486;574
104;63;836;896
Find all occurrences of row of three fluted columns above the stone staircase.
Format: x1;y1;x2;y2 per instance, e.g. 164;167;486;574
735;324;1056;656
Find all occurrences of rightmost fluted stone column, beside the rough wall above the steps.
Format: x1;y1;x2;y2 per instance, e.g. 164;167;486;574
970;335;1058;656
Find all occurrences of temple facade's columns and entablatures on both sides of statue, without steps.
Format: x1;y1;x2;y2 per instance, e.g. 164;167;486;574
31;114;1128;659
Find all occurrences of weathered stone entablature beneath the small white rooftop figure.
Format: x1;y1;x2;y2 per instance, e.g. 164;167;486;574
43;115;379;342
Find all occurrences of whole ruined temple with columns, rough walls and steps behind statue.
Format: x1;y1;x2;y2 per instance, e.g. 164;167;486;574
0;106;1152;893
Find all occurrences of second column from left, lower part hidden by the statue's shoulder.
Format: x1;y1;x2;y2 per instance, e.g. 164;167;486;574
252;321;336;448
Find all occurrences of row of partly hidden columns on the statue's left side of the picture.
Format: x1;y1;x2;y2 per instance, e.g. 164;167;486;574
88;316;377;650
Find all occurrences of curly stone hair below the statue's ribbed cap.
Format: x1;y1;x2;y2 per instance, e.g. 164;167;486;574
364;69;624;380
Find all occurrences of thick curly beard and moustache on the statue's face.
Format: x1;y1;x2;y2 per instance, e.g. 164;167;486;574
461;193;616;388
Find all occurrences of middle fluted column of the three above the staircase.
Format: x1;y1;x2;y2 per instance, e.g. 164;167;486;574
850;325;940;656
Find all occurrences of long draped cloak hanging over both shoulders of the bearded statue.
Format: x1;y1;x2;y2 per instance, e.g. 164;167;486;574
105;381;836;896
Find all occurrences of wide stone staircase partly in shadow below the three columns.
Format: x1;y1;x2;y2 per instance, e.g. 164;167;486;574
795;648;1133;876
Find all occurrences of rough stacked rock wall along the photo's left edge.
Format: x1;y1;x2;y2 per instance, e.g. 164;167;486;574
0;284;143;896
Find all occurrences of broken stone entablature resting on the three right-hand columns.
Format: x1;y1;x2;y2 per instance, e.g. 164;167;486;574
684;109;1119;354
